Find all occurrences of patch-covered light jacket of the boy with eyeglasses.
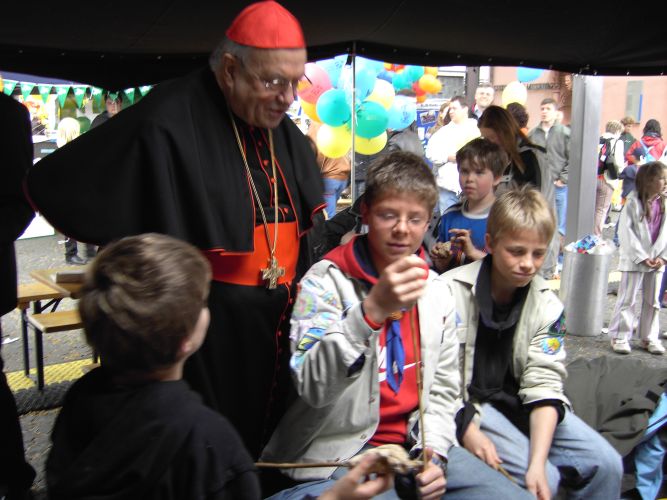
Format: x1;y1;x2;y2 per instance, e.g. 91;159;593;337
262;260;460;481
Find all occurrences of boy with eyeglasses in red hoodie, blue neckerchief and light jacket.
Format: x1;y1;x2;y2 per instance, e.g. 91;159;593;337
262;152;527;499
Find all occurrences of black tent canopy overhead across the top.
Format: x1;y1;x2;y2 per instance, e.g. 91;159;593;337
0;0;667;89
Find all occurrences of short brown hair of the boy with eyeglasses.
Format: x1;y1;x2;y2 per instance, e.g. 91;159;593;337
364;151;438;214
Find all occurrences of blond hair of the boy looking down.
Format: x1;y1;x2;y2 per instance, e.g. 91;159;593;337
486;186;556;242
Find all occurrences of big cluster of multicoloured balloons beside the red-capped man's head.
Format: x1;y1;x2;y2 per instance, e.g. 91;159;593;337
297;56;442;158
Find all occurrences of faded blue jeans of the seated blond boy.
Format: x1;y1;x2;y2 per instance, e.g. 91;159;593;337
480;403;623;500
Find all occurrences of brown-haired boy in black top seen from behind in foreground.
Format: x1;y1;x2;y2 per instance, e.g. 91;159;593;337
47;234;260;500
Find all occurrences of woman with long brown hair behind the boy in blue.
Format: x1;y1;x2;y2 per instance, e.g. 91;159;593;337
478;106;545;196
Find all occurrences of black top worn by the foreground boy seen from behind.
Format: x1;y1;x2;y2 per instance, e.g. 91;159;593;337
46;368;260;500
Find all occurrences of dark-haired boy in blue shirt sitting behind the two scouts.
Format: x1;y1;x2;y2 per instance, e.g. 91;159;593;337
430;138;509;273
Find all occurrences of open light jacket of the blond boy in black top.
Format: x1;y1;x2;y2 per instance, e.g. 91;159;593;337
436;260;570;425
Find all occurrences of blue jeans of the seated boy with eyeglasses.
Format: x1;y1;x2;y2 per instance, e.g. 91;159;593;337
269;446;534;500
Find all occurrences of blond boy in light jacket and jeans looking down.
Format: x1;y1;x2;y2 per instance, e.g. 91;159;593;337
437;187;623;500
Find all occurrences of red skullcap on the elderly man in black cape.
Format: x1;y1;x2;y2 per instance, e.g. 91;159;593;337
225;1;306;49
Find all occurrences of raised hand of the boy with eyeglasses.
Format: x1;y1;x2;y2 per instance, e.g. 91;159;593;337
363;255;428;323
